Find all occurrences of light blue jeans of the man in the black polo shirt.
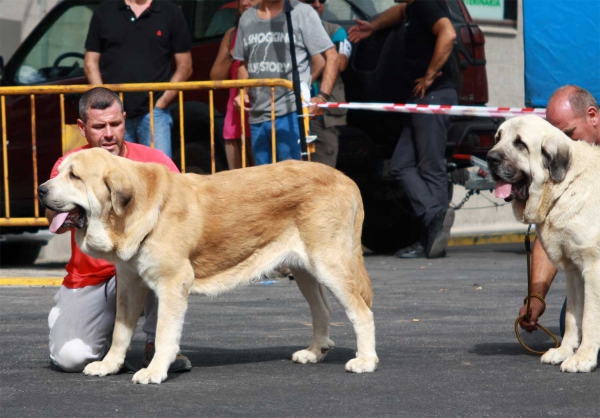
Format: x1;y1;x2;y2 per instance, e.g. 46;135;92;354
125;107;173;158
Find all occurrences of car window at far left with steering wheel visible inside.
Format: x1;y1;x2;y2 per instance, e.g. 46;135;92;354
15;5;94;84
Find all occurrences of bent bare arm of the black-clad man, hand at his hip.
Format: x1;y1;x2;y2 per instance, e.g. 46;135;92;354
413;17;456;98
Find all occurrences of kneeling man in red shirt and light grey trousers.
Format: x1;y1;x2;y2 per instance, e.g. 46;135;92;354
46;87;192;372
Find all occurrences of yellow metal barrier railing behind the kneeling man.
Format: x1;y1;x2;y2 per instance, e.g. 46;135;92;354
0;79;311;227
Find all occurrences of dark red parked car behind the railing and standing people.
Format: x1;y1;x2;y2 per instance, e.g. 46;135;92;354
0;0;499;260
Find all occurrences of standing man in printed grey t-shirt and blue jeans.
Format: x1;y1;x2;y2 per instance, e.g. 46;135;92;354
234;0;338;165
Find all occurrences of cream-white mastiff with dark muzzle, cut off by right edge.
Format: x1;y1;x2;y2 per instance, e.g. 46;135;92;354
488;116;600;372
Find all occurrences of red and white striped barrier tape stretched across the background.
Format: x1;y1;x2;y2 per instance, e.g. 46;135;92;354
317;103;546;118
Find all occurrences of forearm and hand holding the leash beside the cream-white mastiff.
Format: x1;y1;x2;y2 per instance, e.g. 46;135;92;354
519;239;558;332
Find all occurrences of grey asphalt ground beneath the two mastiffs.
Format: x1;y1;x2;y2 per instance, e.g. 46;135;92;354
0;244;600;417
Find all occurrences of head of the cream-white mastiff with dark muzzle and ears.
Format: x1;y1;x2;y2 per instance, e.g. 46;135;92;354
487;115;571;219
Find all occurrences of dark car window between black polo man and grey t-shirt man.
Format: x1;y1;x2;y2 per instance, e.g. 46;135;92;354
194;0;238;41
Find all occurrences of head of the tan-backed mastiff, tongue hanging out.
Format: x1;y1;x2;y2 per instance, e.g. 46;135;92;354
38;148;134;253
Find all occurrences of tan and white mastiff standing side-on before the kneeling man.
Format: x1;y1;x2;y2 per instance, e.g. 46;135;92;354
40;149;379;384
